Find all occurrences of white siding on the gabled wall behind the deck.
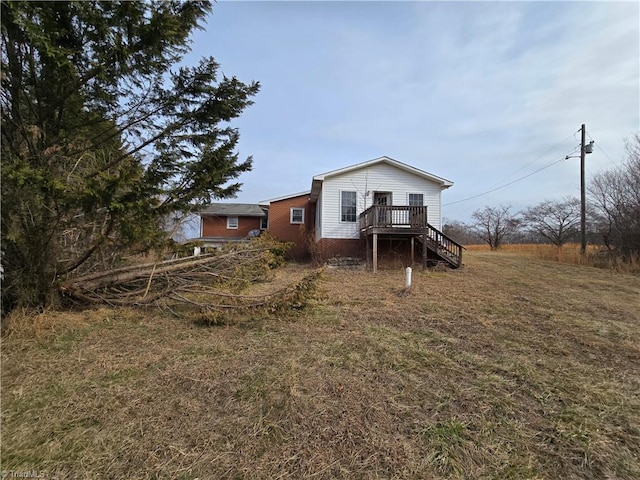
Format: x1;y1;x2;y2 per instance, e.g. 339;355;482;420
316;163;441;238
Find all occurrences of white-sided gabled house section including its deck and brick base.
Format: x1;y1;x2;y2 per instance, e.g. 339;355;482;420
310;157;462;270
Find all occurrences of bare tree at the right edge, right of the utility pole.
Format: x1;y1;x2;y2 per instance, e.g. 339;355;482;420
589;134;640;256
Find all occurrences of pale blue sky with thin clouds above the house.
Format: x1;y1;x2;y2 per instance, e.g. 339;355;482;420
186;1;640;221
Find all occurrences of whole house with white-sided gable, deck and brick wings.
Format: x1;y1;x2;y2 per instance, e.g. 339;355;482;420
202;157;462;270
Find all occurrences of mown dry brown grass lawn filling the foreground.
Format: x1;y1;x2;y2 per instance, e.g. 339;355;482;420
1;251;640;480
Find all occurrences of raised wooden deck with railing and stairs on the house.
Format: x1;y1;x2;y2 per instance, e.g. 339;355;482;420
359;205;463;271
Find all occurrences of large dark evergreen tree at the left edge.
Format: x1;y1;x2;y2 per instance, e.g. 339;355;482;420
1;1;259;310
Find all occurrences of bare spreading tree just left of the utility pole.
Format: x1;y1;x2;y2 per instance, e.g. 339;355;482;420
522;197;580;248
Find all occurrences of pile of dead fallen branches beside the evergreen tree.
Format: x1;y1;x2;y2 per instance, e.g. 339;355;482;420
61;247;319;312
